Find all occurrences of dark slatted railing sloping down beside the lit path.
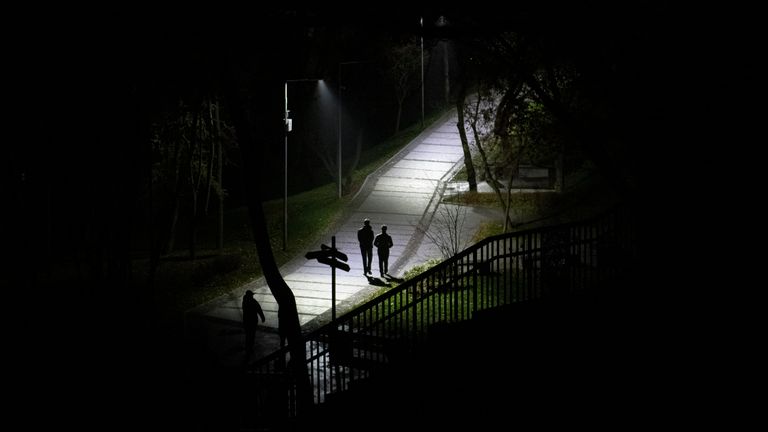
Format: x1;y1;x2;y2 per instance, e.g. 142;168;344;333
250;203;637;418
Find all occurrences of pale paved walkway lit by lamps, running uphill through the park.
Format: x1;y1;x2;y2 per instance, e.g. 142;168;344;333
186;110;474;365
